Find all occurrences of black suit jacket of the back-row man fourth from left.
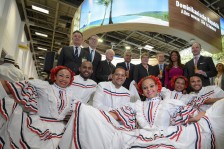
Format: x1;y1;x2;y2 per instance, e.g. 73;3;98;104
116;62;135;89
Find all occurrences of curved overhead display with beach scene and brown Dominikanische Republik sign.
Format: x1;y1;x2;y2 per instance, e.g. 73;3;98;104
74;0;223;54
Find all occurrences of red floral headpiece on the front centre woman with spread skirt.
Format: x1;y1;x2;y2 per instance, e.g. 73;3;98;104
138;75;162;95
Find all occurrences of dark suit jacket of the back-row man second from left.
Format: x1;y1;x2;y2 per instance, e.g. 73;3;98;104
83;47;102;82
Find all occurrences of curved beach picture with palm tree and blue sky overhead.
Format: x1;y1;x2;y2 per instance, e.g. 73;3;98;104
80;0;169;31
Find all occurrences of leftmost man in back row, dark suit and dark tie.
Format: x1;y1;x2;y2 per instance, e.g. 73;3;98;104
57;31;88;74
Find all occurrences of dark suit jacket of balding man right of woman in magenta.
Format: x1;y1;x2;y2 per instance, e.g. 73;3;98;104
184;56;217;86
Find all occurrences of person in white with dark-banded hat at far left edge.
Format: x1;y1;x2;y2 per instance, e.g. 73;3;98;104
0;55;24;82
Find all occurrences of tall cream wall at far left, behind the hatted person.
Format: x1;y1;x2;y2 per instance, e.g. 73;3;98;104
0;0;38;78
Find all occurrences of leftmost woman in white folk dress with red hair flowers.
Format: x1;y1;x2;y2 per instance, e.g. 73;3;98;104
0;66;74;149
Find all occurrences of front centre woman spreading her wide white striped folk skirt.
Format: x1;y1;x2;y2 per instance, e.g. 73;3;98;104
59;76;224;149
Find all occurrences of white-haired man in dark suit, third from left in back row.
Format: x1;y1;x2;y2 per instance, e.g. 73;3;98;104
96;49;115;82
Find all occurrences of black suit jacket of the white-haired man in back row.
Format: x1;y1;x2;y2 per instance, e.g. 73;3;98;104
96;60;115;82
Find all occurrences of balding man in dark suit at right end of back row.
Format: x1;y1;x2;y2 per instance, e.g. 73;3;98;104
184;43;217;86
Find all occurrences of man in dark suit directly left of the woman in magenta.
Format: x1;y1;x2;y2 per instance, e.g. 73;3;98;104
155;53;167;87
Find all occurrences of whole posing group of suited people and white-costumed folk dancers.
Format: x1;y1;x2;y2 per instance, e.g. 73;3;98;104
0;31;224;149
